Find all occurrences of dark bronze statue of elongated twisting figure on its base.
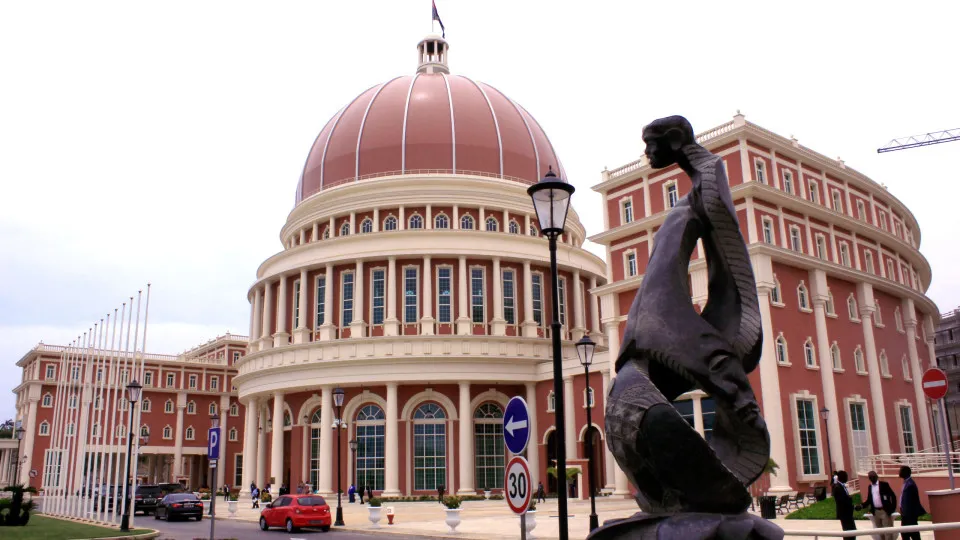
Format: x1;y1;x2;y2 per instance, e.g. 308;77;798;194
590;116;783;540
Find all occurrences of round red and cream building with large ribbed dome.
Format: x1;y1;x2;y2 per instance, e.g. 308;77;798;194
233;35;612;496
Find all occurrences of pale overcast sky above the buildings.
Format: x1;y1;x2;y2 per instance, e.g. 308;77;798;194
0;0;960;419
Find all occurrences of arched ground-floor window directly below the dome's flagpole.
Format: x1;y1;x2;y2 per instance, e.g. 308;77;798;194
413;403;447;491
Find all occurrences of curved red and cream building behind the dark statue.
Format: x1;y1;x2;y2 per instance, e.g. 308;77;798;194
591;113;938;490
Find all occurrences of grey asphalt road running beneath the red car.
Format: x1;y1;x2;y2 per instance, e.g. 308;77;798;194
144;516;428;540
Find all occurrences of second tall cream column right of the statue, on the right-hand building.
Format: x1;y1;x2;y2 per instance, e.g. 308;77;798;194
810;270;846;471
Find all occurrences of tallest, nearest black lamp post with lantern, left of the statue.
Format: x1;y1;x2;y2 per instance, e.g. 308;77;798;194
527;167;575;540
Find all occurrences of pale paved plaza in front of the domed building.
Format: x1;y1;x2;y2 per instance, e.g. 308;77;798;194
217;497;933;540
